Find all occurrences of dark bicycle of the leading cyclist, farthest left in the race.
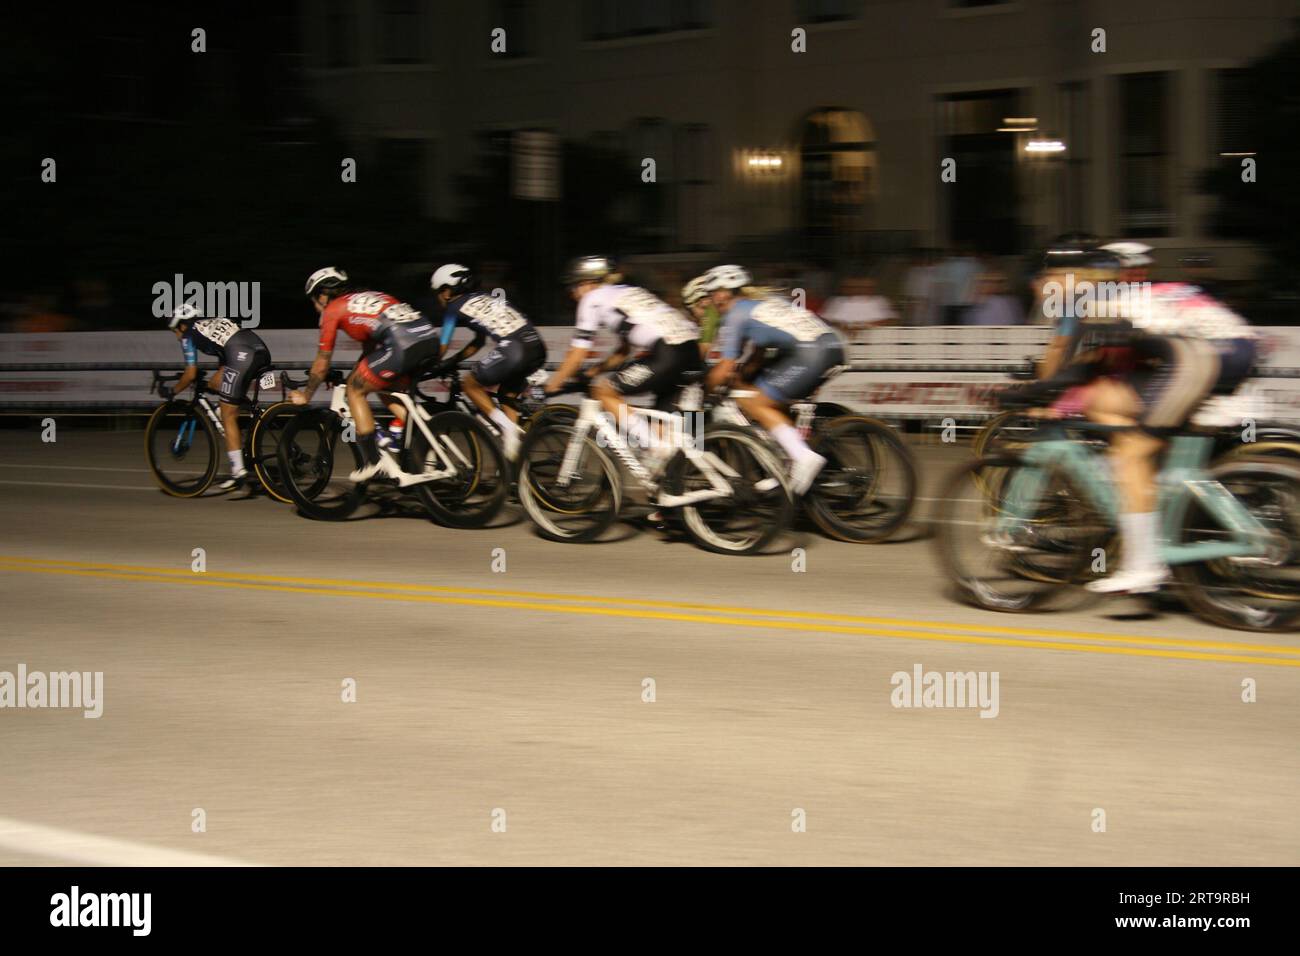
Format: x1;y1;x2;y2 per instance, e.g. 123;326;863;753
144;369;298;502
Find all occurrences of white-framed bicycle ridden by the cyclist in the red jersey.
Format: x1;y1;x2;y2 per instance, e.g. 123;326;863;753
278;367;510;528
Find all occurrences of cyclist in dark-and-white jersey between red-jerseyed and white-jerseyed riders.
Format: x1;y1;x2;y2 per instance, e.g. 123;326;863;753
429;263;546;460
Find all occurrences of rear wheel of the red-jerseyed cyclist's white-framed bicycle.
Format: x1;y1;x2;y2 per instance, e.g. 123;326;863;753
403;411;510;528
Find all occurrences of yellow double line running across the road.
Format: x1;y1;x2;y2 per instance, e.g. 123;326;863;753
0;555;1300;667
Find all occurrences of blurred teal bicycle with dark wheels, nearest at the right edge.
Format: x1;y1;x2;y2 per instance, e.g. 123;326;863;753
936;419;1300;631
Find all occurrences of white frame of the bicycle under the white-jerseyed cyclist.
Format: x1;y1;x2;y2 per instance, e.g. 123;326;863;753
558;398;740;507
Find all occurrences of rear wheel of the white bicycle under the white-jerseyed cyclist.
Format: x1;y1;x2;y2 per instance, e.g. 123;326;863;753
663;425;794;554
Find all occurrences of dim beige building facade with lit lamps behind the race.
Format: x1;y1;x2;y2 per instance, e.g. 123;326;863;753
300;0;1300;273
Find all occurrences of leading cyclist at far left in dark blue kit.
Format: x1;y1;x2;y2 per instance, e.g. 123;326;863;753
160;303;270;492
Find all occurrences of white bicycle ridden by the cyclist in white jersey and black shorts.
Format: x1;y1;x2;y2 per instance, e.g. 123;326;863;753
519;380;794;554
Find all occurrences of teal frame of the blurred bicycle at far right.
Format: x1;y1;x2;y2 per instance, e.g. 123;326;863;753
997;425;1271;566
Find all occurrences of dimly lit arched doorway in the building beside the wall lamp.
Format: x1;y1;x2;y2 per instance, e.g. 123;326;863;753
800;107;878;259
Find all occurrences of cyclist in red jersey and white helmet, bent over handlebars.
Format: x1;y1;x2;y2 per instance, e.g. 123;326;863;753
290;267;438;483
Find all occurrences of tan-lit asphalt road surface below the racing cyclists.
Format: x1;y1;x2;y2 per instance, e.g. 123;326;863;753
0;427;1300;865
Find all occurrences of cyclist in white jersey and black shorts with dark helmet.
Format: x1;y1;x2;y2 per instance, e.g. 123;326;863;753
545;256;703;460
